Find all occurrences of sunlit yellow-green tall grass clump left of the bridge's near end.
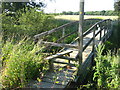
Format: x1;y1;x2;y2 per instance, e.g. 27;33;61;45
1;40;47;88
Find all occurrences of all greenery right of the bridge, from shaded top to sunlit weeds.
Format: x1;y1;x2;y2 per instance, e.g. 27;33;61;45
79;20;120;90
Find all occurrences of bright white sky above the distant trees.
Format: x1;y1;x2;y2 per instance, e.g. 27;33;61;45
45;0;114;13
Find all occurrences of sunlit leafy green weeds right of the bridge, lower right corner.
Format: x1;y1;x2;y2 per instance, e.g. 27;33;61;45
93;45;120;89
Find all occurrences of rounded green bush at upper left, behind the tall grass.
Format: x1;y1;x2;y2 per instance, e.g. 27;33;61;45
2;8;55;40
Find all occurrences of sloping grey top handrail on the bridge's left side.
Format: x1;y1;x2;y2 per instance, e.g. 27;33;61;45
34;21;78;39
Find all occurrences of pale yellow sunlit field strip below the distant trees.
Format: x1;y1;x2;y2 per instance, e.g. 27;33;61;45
55;15;118;20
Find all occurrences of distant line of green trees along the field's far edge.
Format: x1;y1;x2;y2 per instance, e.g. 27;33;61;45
50;10;117;16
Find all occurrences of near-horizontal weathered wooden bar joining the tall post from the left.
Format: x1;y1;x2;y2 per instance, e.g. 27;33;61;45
39;41;78;48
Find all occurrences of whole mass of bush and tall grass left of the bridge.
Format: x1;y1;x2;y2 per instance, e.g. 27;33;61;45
0;8;56;89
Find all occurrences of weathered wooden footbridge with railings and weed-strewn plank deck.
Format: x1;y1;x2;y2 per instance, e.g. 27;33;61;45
27;19;112;88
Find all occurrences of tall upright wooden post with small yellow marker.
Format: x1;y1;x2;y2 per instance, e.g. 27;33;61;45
78;0;84;73
